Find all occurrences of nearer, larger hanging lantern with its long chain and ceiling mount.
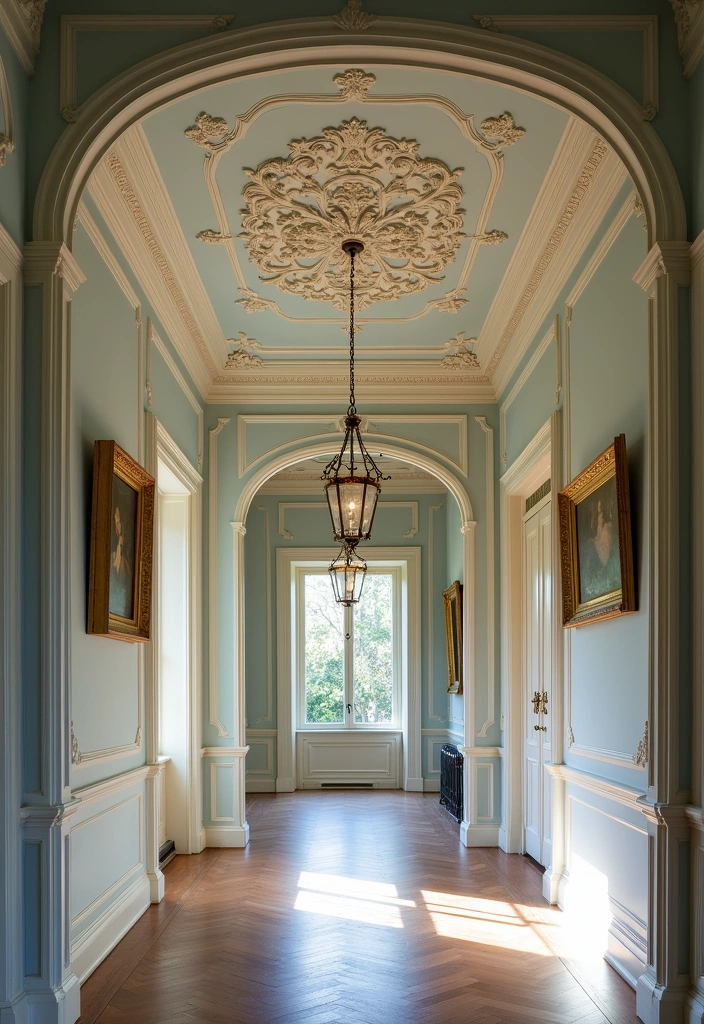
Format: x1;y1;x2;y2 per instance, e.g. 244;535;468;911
322;239;388;548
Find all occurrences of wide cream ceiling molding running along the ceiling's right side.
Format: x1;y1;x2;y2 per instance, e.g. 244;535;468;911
476;119;627;394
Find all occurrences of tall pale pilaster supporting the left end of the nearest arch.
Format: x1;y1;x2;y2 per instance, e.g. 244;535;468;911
21;242;85;1024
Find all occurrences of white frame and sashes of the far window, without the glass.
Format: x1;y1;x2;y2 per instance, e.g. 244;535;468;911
292;559;401;732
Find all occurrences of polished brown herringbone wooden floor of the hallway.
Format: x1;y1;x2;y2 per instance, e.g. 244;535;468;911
76;792;636;1024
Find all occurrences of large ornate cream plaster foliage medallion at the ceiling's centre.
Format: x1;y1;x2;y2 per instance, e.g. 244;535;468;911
241;118;465;310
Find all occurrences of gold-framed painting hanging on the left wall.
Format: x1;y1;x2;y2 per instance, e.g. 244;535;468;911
88;441;155;642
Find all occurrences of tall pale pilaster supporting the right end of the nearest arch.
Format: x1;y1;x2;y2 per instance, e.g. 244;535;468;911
634;242;690;1024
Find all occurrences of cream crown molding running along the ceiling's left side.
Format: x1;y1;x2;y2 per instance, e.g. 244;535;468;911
87;160;212;397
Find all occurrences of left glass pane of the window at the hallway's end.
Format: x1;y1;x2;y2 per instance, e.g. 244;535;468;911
305;572;345;725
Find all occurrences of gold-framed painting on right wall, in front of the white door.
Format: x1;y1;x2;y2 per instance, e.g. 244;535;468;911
558;434;636;627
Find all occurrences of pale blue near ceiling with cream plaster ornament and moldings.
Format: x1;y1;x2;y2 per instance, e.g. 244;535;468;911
82;66;626;401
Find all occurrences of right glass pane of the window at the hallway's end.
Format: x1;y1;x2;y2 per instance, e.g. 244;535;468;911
354;572;394;723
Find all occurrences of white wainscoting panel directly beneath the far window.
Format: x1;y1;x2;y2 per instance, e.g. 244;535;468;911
297;732;402;790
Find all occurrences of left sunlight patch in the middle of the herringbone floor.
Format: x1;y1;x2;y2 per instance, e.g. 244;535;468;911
294;871;415;928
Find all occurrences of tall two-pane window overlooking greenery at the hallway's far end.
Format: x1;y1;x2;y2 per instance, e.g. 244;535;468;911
296;564;400;728
